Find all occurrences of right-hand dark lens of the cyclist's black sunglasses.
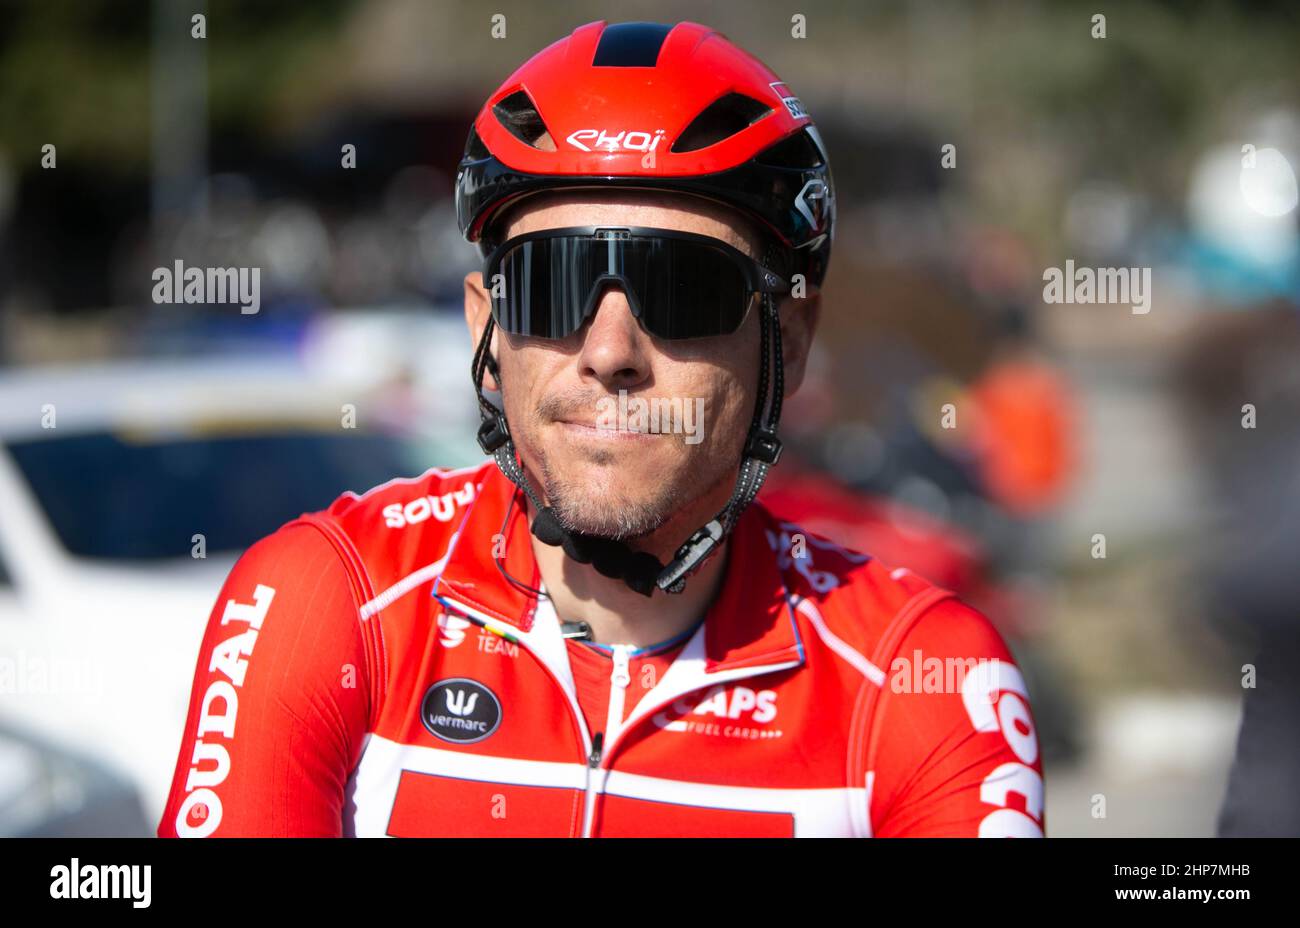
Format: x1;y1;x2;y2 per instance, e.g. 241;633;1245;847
628;239;749;338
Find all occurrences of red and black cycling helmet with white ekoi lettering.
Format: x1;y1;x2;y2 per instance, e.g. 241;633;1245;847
456;22;835;285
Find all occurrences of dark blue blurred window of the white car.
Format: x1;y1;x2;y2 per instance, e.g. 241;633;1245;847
0;430;445;556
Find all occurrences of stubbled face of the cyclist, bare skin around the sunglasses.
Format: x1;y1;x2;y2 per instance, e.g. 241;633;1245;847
465;192;800;537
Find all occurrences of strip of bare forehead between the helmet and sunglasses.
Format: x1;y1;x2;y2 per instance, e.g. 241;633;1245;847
501;190;762;257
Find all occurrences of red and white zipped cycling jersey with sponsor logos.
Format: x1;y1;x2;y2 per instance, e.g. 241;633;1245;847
159;461;1044;837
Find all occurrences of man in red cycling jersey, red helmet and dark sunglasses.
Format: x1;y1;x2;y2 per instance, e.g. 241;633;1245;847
159;22;1043;836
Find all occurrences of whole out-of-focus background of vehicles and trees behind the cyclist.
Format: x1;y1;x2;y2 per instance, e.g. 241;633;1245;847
0;0;1300;836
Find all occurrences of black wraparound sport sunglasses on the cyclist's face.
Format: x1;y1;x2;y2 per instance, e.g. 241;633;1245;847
484;226;789;339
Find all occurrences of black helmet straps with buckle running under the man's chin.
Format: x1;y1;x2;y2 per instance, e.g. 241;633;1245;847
471;294;785;597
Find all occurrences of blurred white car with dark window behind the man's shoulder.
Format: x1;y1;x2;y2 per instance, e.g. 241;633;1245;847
0;313;480;823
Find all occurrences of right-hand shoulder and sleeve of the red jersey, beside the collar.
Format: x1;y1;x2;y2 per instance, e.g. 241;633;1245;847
748;501;1044;837
